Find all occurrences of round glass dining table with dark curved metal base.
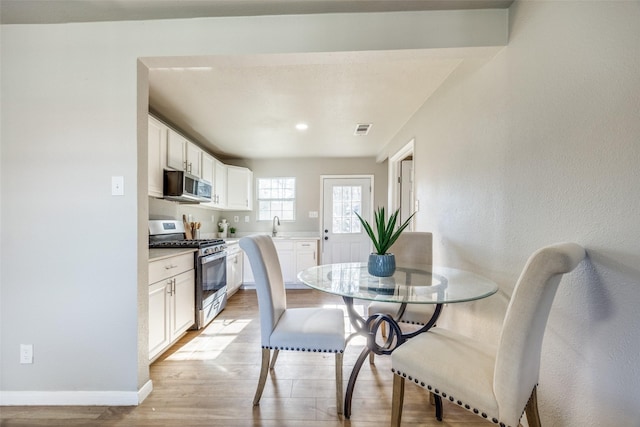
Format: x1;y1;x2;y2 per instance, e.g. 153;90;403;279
298;262;498;419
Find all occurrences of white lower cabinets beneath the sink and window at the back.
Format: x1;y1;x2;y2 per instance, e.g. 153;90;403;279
242;239;318;285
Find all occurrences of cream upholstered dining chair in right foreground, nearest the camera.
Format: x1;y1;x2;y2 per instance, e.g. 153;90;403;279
391;243;585;427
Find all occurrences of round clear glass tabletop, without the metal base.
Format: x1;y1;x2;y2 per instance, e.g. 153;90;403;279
298;262;498;304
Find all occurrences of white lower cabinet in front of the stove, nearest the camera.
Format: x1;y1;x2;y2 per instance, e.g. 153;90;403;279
149;253;195;360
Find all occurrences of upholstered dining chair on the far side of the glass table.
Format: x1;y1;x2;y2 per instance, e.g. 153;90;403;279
367;231;435;363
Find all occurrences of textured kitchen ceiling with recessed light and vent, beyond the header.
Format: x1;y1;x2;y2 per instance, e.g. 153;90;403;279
149;52;461;158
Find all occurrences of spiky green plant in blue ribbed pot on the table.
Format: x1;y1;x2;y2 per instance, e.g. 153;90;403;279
355;207;415;277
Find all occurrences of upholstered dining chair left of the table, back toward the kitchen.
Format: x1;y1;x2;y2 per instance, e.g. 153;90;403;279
240;235;345;414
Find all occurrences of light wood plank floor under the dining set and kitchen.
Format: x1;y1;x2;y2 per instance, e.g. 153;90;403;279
0;290;493;427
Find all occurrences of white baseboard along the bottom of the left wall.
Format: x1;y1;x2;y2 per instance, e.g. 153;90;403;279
0;380;153;406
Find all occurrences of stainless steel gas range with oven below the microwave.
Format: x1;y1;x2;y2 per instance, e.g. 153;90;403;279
149;220;227;329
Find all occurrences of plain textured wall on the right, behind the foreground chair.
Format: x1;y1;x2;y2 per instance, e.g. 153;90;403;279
388;1;640;427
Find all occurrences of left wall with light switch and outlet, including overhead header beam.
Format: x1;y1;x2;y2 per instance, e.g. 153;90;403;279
0;11;507;404
